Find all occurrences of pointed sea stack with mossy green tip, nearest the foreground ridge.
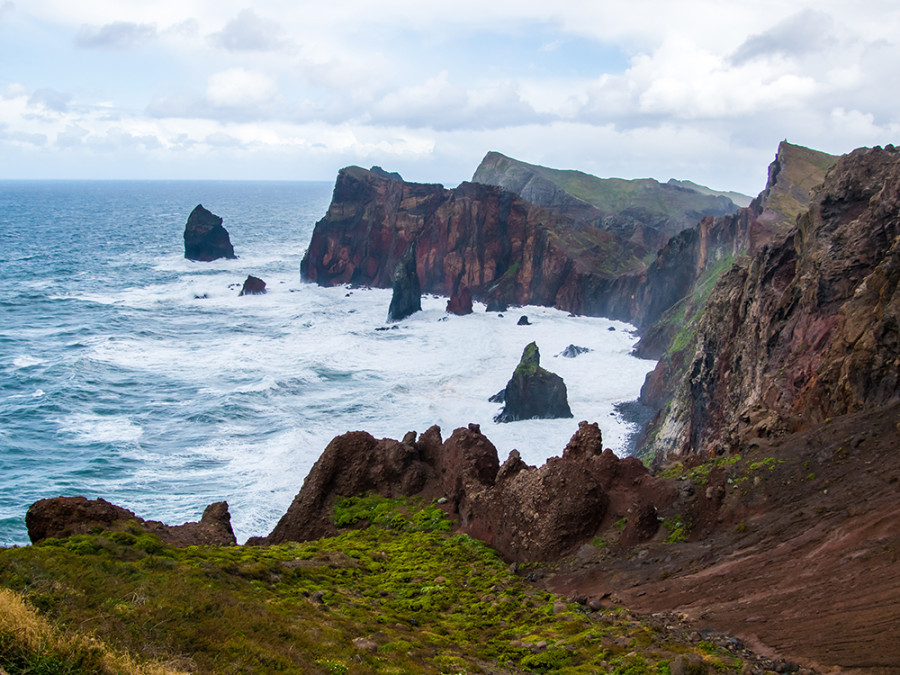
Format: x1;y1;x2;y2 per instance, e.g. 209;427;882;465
494;342;572;422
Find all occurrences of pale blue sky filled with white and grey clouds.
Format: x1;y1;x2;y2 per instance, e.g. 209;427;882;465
0;0;900;195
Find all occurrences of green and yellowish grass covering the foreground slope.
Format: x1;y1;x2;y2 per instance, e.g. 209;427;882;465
0;497;739;675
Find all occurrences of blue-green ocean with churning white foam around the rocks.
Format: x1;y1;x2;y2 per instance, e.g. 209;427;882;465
0;181;654;546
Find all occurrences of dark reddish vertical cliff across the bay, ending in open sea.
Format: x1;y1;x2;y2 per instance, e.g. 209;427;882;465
300;167;644;314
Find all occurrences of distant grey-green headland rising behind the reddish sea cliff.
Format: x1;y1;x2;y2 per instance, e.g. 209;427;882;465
472;152;737;255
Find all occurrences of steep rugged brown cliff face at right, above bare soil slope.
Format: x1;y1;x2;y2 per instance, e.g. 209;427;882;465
648;146;900;457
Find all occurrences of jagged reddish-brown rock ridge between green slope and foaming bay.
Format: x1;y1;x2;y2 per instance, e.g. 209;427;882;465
255;422;677;562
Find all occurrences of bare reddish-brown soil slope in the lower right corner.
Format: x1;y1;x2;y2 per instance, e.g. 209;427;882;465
542;404;900;674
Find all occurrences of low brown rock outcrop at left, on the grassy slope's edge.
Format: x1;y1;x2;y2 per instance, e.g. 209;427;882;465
25;497;237;547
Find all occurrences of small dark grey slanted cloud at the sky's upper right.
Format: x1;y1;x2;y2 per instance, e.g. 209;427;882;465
731;9;834;65
